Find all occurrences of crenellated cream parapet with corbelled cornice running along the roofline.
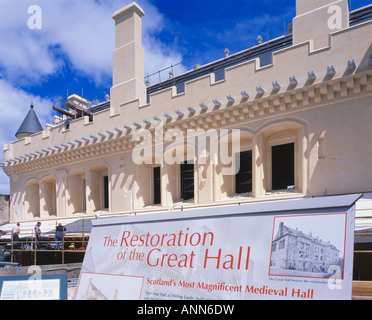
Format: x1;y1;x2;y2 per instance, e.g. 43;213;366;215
4;2;372;174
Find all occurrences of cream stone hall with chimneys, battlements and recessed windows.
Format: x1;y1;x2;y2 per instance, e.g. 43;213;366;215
4;0;372;222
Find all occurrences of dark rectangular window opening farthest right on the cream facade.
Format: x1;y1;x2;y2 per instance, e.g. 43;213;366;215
271;143;295;190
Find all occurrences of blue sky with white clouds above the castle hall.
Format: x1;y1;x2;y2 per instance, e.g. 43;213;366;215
0;0;371;194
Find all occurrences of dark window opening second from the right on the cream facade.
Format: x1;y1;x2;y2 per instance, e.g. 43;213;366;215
235;150;252;193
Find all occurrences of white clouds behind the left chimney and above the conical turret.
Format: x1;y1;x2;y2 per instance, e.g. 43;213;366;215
0;0;185;193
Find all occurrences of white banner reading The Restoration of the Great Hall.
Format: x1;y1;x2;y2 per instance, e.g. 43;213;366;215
76;196;354;300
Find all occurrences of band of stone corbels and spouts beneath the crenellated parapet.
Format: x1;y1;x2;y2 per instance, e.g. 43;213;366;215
3;70;372;177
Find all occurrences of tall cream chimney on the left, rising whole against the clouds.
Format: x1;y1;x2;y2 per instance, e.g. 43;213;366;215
110;2;146;114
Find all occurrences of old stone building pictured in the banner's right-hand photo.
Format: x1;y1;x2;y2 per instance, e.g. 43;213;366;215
271;222;342;273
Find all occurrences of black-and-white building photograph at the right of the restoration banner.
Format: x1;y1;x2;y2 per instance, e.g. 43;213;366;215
269;213;346;279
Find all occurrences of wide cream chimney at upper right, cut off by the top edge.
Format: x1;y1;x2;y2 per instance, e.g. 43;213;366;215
293;0;349;50
